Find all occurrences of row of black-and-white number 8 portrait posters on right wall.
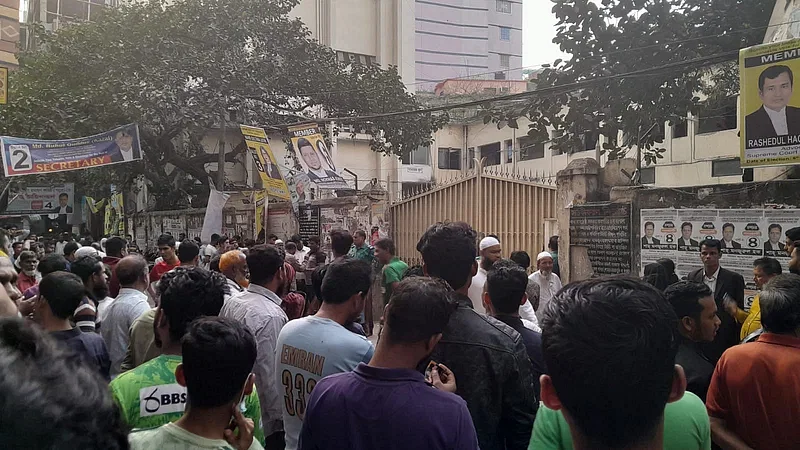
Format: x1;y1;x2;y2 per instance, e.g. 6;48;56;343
640;208;800;309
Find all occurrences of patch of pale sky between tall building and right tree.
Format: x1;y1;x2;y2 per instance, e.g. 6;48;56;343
522;0;564;68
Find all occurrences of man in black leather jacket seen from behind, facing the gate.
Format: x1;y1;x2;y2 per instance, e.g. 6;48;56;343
417;222;538;450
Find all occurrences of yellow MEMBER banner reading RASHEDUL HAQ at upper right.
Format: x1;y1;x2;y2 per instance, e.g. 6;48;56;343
739;39;800;167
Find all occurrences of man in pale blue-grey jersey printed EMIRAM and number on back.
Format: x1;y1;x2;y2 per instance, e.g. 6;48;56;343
277;259;374;450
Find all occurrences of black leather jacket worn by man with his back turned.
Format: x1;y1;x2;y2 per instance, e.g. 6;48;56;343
424;295;539;450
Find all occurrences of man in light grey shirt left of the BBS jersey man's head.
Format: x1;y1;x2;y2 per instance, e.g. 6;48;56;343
100;255;150;378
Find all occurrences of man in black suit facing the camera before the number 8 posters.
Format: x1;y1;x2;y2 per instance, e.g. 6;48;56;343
687;239;744;364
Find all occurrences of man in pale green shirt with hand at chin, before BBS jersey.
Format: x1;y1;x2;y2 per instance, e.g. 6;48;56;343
128;317;263;450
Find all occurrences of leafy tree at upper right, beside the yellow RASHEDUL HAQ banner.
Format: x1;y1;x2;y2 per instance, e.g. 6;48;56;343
489;0;772;163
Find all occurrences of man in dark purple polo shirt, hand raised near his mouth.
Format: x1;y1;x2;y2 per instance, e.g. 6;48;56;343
300;277;478;450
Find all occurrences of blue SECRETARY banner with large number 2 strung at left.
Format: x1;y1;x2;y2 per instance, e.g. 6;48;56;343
0;124;142;177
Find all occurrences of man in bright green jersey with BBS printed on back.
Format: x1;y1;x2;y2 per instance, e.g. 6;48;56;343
110;267;264;443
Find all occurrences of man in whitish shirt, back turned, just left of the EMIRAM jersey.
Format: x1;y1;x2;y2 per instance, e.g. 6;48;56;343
220;245;289;449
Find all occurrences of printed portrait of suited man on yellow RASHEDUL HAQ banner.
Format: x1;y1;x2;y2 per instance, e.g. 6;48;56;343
745;65;800;141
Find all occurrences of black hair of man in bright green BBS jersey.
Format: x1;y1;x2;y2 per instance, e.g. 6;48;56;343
158;266;230;342
